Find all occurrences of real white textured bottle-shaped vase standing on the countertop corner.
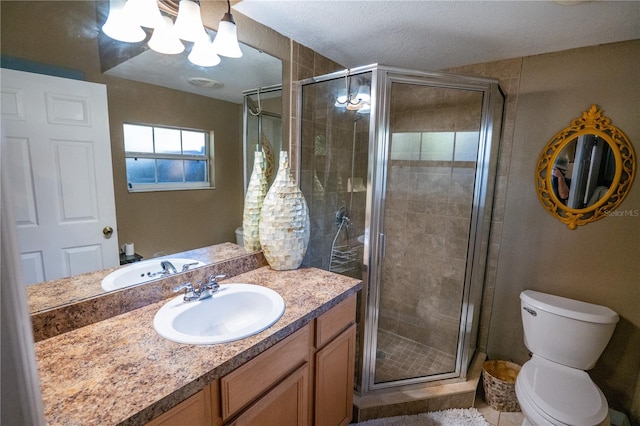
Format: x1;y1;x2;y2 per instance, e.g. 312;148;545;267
260;151;310;271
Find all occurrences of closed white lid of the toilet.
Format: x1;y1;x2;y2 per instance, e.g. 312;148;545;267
517;357;609;425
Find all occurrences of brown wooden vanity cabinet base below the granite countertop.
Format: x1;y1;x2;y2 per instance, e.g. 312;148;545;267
149;295;356;426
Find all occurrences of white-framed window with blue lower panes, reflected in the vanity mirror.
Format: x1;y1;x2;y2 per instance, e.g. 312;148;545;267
123;123;214;192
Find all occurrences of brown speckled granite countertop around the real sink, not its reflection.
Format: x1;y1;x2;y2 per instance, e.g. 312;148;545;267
35;266;362;426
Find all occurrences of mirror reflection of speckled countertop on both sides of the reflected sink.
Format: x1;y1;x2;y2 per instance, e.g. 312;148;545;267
27;243;247;313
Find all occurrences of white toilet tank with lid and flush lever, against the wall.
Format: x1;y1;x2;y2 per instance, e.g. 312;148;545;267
520;290;619;370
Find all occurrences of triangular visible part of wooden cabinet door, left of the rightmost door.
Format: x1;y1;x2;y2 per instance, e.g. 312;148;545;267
229;363;309;426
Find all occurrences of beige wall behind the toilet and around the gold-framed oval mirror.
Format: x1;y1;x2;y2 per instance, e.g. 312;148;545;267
454;40;640;422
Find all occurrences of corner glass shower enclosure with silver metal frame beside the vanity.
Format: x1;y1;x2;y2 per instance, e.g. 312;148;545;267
298;65;504;393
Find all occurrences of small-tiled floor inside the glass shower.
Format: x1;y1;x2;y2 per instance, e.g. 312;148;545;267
375;329;456;383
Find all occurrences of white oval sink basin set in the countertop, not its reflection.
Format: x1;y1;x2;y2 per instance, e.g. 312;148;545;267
153;284;284;345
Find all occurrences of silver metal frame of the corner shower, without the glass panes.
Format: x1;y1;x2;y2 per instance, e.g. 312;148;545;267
297;64;505;394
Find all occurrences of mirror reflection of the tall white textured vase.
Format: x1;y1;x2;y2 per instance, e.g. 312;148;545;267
242;151;267;252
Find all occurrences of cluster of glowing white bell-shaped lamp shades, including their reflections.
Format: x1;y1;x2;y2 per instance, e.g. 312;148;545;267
102;0;242;67
